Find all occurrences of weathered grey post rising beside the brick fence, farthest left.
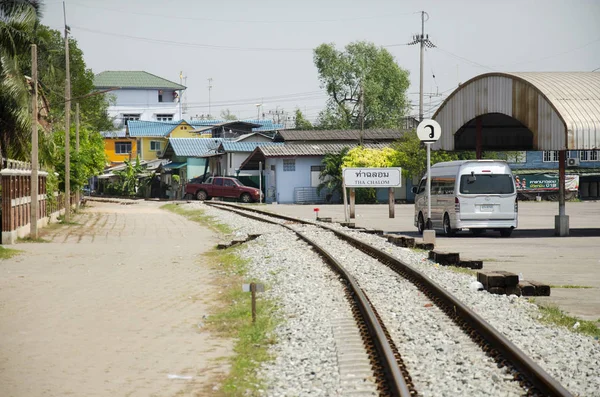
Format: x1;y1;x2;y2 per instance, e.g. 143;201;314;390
29;44;39;239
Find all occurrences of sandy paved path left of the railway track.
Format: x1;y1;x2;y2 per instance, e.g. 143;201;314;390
0;202;232;397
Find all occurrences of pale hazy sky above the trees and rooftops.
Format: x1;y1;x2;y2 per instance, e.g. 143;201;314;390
42;0;600;121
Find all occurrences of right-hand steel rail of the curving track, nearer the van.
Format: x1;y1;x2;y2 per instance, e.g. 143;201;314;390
205;203;573;397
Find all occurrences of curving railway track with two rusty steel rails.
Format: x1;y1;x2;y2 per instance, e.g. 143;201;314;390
205;203;571;396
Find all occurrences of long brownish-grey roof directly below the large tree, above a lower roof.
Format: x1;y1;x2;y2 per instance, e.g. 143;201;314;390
279;129;404;142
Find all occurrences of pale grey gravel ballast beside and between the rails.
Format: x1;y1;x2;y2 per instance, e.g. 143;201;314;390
188;203;600;396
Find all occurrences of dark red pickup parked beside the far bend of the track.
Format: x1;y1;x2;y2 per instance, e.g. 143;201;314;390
185;176;262;203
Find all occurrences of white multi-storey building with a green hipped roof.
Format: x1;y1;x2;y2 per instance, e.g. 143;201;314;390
94;71;186;127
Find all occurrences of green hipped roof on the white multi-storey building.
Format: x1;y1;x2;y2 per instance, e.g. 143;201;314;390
94;70;186;90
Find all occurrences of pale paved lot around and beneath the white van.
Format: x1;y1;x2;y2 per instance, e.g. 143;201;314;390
264;202;600;321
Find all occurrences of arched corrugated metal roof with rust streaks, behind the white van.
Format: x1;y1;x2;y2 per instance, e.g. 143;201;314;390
432;72;600;150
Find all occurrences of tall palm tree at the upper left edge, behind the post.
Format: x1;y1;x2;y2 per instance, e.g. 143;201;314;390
0;0;41;159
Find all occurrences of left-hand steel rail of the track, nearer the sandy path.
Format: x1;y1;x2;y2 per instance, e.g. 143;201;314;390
206;203;414;397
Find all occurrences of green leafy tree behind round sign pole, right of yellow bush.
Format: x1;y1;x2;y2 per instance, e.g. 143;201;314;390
392;130;475;178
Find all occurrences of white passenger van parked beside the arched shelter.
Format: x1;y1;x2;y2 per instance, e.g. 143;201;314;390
412;160;518;237
